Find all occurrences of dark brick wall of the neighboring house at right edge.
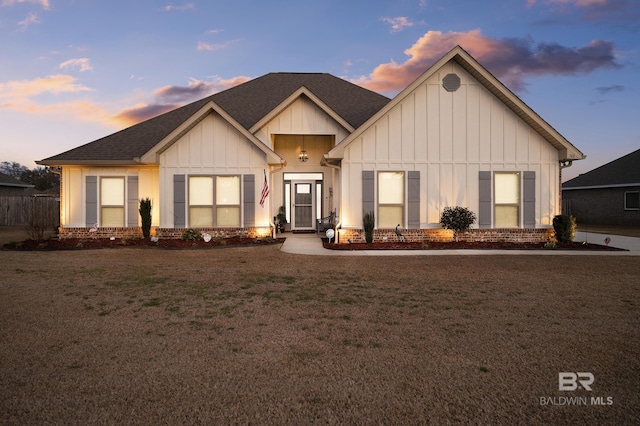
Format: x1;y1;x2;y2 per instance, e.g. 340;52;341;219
562;186;640;227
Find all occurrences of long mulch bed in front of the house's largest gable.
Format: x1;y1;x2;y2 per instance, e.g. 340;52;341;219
322;239;627;251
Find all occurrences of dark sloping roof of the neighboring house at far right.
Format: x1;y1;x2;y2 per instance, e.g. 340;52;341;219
562;149;640;190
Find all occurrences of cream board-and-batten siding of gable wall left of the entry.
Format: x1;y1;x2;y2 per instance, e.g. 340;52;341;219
160;113;270;228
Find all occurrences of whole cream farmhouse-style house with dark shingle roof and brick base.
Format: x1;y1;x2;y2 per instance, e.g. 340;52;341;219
38;47;584;242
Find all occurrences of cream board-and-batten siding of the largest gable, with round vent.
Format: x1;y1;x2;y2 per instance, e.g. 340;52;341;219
342;61;560;228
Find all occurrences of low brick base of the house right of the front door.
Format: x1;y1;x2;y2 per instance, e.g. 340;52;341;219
338;228;555;244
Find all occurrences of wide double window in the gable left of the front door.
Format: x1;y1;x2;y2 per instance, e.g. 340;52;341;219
189;176;240;228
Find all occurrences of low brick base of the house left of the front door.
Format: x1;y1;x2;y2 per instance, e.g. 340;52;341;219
58;227;271;239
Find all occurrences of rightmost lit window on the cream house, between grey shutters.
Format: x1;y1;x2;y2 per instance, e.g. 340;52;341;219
494;173;520;228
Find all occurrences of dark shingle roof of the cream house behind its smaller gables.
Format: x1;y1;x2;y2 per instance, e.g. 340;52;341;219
37;73;390;165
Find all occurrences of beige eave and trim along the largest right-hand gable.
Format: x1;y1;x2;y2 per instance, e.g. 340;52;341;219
325;46;586;161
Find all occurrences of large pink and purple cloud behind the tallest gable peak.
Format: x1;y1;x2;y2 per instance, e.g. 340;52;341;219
355;30;619;93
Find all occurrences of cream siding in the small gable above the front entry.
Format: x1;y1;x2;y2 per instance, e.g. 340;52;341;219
255;96;349;148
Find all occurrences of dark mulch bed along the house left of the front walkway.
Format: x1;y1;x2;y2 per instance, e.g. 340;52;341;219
2;237;285;251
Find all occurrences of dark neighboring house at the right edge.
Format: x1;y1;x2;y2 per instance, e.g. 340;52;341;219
562;149;640;227
